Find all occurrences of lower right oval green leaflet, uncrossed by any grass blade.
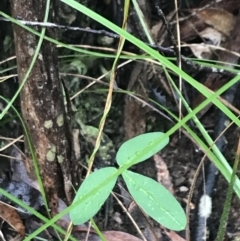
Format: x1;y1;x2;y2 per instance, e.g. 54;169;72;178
122;171;187;231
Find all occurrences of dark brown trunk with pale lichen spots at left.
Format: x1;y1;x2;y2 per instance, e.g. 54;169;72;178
11;0;72;215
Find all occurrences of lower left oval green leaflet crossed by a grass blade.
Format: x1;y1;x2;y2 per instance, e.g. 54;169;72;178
69;167;117;225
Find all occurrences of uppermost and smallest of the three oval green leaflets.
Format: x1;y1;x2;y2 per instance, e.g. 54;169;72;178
116;132;169;166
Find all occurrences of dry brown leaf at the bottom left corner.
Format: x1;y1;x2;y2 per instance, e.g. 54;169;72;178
0;201;25;237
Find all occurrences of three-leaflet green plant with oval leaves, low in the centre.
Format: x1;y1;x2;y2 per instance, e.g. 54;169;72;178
70;132;186;230
